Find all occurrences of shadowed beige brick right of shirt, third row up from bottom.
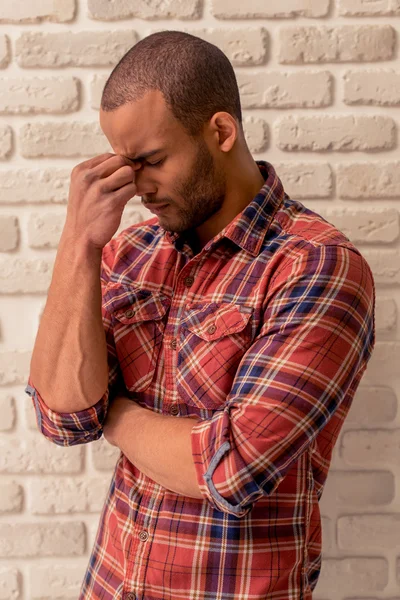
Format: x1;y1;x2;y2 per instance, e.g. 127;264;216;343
323;471;396;510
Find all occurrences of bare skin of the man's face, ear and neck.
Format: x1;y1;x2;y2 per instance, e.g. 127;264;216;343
100;90;264;252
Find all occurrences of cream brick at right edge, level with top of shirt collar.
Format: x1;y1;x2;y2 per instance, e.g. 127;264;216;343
337;161;400;199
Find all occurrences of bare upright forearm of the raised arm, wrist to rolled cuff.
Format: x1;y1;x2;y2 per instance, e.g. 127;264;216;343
30;230;108;413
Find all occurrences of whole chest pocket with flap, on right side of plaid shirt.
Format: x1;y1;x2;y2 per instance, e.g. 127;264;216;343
177;303;253;409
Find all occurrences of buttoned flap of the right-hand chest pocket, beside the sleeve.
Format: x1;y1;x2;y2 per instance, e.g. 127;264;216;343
183;303;253;342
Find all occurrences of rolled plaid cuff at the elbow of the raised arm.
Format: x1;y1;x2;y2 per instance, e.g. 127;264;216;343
25;379;109;446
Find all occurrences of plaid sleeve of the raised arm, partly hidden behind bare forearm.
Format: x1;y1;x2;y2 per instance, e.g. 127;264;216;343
25;240;122;446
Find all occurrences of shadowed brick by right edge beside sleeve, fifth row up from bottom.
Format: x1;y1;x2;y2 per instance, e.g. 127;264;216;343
345;385;397;427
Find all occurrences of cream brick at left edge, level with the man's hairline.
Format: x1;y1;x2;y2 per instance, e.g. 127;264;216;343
0;77;80;115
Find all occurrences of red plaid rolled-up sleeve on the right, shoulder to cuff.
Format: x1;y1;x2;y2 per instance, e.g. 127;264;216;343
191;245;375;517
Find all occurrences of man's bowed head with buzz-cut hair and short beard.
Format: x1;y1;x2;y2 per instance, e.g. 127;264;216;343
100;31;255;239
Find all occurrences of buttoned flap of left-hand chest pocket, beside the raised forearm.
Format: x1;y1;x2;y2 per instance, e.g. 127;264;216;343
103;284;171;325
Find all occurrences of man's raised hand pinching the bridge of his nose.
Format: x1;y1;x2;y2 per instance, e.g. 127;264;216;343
63;153;140;249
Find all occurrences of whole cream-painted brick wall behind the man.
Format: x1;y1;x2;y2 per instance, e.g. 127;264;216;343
0;0;400;600
